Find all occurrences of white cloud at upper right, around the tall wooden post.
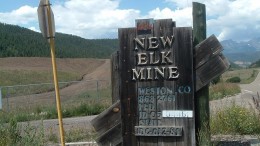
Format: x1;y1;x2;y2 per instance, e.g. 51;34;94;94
166;0;260;41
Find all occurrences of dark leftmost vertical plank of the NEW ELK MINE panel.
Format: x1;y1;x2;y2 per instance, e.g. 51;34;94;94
118;28;137;146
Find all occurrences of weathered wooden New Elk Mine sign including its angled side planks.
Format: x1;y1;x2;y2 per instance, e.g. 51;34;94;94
92;16;230;146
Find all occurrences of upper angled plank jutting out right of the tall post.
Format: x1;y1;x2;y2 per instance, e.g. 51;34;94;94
194;35;223;69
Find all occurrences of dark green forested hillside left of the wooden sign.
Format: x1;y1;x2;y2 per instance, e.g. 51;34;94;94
0;23;118;58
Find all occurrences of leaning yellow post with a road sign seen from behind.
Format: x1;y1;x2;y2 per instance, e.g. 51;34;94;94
38;0;65;146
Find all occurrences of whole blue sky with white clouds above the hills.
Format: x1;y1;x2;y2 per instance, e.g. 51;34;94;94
0;0;260;41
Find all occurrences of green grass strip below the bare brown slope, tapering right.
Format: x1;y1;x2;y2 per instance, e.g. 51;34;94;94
0;70;81;97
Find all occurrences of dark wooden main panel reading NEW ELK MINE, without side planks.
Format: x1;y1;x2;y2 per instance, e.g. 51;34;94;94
119;19;195;146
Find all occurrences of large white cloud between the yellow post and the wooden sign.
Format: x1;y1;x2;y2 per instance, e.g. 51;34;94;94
53;0;140;38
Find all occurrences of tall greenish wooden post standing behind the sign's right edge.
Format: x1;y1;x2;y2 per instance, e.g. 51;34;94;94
192;2;210;145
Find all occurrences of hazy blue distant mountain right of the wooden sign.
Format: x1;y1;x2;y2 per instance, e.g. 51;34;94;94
221;38;260;67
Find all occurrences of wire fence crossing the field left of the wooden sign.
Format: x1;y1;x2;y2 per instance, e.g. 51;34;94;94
0;80;111;112
